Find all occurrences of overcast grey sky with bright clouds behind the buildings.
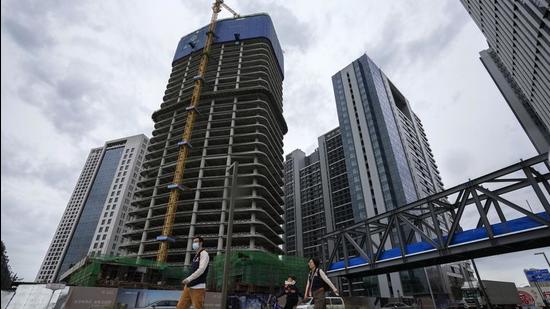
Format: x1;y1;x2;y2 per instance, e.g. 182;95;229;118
1;0;550;284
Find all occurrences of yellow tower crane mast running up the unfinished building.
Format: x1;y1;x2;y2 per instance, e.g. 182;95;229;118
157;0;239;263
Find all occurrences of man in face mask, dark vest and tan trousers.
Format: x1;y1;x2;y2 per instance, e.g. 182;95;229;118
176;236;210;309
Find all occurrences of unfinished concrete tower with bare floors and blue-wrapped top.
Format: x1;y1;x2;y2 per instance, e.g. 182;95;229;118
124;10;287;265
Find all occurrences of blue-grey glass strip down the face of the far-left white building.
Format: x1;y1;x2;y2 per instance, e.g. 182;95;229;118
58;147;124;275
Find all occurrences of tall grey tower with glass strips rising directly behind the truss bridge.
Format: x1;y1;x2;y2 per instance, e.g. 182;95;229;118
332;55;445;297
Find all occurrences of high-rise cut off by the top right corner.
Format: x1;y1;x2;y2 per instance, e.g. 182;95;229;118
461;0;550;153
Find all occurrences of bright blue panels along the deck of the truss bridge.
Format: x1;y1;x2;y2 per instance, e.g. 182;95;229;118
328;212;550;271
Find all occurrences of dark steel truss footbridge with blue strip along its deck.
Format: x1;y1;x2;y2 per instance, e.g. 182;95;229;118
321;154;550;277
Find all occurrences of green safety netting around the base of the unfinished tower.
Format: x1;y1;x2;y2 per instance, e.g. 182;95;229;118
69;251;308;291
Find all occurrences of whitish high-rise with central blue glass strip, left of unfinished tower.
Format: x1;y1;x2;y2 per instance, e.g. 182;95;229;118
36;135;148;282
